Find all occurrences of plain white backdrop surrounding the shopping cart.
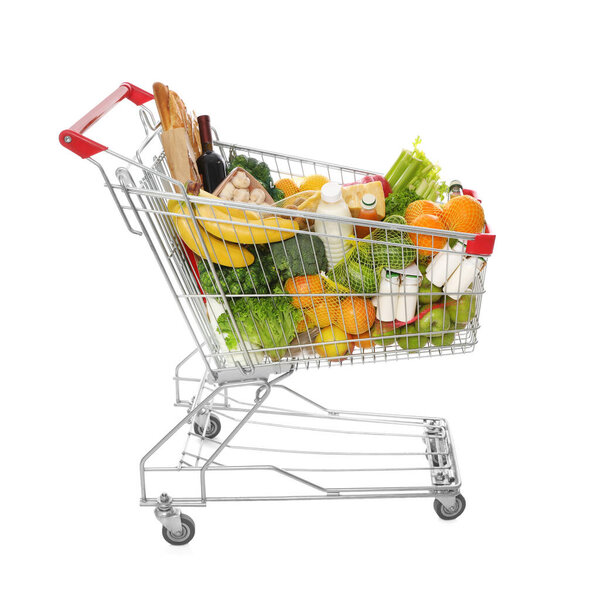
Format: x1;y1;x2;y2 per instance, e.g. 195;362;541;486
0;0;600;596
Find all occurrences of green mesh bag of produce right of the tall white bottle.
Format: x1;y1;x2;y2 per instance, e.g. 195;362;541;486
327;215;417;294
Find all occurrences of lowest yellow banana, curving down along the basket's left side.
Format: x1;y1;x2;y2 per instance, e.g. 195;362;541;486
167;199;254;267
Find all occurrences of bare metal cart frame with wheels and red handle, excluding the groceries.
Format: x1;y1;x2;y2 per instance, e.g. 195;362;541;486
59;83;495;545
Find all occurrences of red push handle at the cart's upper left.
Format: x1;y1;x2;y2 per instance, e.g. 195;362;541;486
58;83;154;158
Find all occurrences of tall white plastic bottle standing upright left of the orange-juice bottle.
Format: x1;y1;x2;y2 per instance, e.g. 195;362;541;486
315;182;354;267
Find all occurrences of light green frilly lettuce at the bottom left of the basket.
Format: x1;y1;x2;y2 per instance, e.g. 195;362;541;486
217;294;302;361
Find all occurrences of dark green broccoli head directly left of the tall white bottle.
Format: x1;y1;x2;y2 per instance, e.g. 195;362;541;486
271;234;327;281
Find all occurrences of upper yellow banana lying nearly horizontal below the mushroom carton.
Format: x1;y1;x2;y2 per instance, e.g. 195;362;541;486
195;204;300;245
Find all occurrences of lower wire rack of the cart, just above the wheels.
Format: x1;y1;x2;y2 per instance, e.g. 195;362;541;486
141;375;461;506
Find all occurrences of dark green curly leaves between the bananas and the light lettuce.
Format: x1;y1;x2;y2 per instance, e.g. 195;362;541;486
196;249;279;294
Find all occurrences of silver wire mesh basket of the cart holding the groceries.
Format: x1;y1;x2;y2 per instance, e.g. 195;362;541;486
106;110;486;372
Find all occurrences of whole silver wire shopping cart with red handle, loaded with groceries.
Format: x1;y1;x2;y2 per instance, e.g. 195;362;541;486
60;83;494;545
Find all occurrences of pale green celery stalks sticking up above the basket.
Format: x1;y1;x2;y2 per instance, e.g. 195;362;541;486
385;137;447;201
